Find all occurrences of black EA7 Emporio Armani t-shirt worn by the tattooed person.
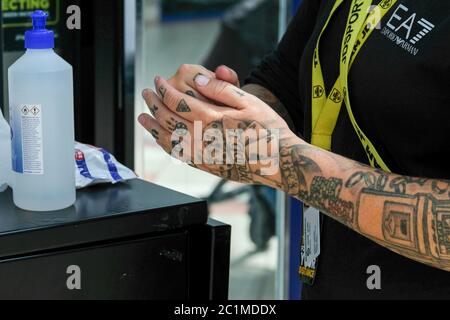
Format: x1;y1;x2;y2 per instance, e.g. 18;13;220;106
248;0;450;299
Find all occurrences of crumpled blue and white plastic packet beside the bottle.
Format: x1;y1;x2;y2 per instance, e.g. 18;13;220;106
75;142;137;189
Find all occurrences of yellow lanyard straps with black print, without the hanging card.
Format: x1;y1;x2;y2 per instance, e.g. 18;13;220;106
311;0;397;172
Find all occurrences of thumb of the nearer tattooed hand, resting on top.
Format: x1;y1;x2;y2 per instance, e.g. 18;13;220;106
194;74;246;109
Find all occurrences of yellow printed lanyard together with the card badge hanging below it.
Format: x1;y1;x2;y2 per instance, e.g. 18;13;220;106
299;0;397;285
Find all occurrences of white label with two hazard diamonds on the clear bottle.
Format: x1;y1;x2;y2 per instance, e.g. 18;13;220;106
19;105;44;175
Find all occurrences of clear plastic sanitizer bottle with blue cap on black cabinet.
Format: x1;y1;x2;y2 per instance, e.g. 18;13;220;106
8;11;75;211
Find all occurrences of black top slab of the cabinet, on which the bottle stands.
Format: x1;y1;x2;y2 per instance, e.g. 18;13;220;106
0;179;208;258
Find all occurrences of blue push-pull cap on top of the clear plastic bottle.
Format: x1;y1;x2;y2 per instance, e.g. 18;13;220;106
25;10;55;49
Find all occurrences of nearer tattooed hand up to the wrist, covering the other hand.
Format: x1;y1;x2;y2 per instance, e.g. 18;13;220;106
139;72;295;187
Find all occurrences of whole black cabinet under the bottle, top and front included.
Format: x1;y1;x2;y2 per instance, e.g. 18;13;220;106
0;180;231;300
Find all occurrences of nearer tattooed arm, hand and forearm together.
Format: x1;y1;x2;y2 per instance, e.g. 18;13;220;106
139;72;450;272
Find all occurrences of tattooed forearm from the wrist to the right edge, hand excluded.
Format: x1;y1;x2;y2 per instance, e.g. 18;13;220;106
280;139;450;271
